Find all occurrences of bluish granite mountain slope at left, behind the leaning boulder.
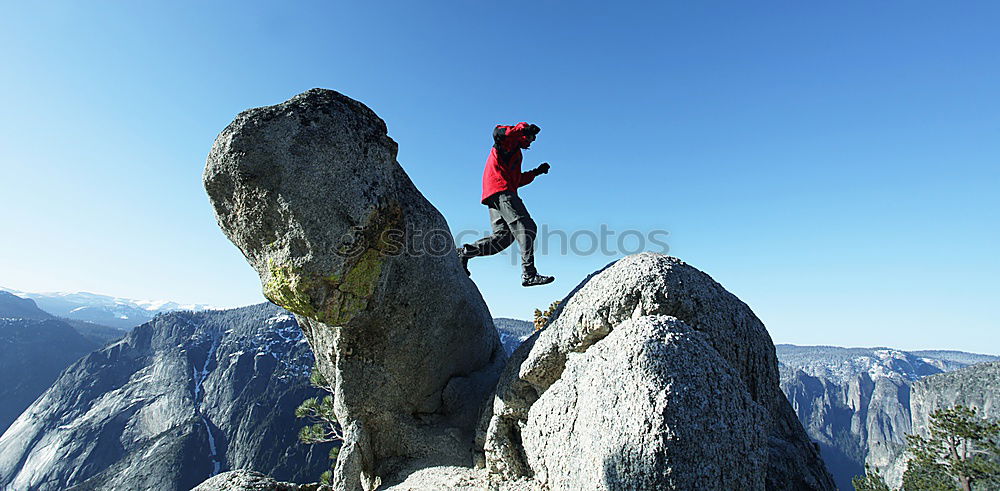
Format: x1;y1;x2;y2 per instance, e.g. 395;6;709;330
0;304;330;491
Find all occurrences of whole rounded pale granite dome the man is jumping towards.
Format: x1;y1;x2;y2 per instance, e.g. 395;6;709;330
477;253;834;489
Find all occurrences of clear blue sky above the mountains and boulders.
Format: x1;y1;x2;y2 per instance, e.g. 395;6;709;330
0;1;1000;354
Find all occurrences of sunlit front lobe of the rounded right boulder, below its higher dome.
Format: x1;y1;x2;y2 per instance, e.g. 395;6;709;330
521;315;766;490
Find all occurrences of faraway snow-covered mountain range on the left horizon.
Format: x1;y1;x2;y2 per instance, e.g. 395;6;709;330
0;287;213;329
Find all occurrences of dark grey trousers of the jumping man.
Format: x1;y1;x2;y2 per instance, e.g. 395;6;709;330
460;191;538;276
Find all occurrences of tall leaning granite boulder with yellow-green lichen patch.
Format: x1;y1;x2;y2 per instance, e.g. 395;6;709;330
204;89;505;489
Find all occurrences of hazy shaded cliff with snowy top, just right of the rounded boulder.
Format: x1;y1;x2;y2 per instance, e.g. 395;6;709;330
777;345;997;489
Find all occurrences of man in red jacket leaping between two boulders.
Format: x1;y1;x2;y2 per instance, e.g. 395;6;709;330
458;123;555;286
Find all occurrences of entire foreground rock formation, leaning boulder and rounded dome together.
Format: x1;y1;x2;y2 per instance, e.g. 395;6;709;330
204;89;834;491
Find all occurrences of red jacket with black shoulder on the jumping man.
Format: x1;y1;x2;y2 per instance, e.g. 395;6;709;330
482;123;535;203
